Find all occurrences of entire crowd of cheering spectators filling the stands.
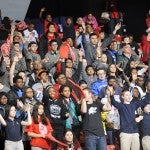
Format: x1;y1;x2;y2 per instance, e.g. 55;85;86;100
0;0;150;150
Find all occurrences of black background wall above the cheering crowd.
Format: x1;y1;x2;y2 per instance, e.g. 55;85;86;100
26;0;150;41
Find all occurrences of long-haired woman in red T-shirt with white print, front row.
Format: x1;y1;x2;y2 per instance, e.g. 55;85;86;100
25;102;53;150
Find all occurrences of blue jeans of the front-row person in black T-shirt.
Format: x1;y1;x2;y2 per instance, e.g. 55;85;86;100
85;135;107;150
